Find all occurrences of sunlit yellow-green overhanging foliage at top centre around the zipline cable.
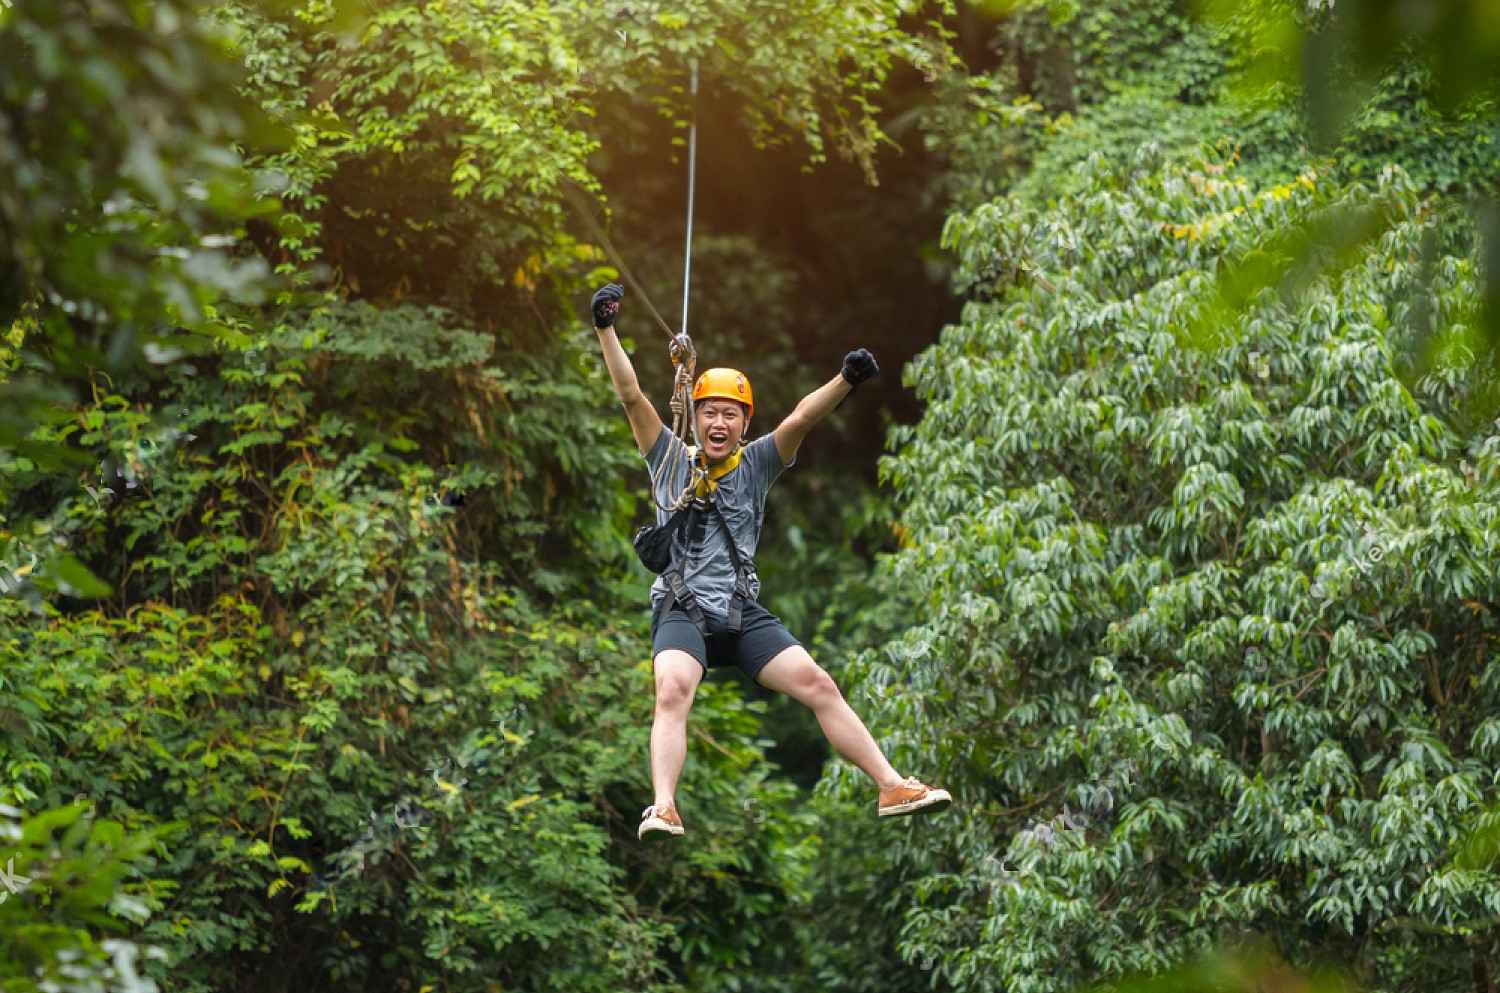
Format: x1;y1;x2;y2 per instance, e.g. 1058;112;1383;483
237;0;945;306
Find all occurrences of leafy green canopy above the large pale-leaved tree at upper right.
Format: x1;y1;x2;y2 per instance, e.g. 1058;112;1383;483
924;0;1500;209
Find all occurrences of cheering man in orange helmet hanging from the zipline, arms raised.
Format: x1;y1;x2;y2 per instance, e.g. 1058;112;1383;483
591;284;953;837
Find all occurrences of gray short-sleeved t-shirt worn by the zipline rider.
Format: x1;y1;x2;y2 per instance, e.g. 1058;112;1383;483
647;426;797;621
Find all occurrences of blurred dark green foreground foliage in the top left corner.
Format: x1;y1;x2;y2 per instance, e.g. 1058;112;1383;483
0;0;275;467
